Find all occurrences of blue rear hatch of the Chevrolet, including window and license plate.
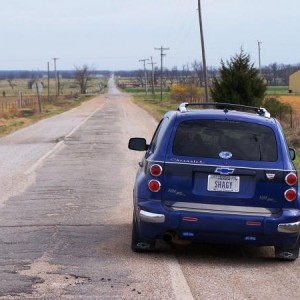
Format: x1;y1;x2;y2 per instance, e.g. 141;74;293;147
162;119;286;216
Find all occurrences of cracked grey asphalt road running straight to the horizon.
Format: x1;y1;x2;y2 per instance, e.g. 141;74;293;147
0;81;300;299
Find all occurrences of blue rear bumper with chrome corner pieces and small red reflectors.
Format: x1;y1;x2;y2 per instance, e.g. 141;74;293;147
137;201;300;246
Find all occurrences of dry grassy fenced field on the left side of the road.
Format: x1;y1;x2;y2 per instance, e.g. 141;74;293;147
0;78;107;136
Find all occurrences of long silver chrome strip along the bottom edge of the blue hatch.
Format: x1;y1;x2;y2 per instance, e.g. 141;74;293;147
171;202;276;217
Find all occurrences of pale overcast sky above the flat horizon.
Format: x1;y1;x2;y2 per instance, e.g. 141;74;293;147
0;0;300;70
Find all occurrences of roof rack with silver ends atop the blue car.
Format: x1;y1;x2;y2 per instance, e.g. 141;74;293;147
178;102;271;118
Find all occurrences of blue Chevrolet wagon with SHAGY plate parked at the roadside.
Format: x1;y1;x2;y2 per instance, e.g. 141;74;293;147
128;103;300;260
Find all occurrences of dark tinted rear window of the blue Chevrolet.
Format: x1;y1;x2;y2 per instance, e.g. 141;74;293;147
173;120;277;162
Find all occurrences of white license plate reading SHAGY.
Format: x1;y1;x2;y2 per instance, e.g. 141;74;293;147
207;175;240;193
